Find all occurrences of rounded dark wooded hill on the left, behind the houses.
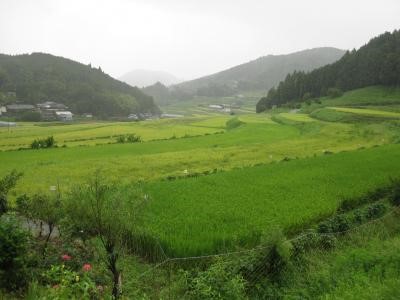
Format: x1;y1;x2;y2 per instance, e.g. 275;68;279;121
0;53;159;117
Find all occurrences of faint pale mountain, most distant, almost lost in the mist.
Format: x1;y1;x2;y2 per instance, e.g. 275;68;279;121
119;70;182;88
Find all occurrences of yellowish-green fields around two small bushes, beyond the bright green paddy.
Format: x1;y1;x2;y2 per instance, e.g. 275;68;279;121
0;114;396;196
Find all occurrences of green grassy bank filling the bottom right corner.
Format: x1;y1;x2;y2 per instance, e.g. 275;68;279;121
276;212;400;299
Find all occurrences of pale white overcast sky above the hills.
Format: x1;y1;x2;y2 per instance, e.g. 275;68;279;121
0;0;400;79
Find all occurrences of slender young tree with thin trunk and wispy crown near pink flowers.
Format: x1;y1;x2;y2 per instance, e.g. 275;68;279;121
66;172;144;299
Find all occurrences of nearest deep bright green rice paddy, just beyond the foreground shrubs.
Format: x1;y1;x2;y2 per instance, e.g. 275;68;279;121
145;145;400;256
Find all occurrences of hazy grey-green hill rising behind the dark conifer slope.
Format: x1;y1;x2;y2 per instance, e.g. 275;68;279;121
173;47;345;96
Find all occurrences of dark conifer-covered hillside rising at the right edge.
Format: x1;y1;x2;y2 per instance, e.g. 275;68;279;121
257;30;400;112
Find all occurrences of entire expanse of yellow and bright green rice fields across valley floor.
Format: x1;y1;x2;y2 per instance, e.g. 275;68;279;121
0;85;400;256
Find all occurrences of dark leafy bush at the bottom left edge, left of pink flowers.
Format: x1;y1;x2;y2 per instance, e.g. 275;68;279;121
0;215;30;291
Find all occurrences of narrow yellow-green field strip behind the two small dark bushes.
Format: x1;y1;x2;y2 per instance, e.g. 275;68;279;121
0;116;229;150
